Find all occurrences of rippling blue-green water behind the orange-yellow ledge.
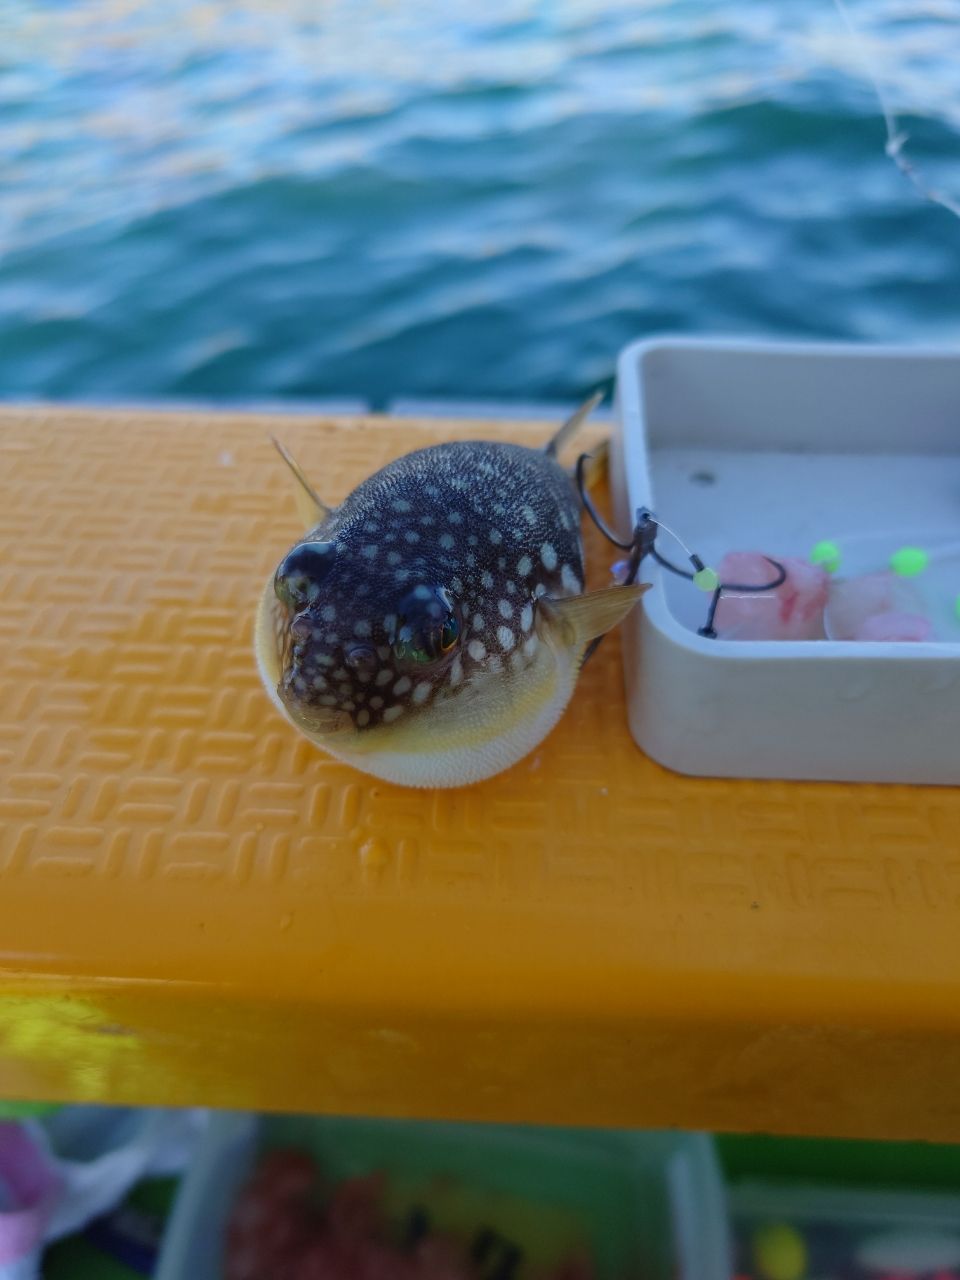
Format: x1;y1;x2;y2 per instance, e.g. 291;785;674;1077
0;0;960;404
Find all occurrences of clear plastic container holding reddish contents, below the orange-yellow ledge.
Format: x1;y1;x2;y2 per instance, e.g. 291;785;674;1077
157;1115;731;1280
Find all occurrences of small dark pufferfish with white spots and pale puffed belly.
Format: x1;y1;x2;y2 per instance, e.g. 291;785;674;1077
256;401;645;787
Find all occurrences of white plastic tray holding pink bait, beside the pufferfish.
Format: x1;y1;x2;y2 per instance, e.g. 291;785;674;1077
612;338;960;785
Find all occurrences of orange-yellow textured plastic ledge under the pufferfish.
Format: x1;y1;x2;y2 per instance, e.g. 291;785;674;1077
0;410;960;1139
